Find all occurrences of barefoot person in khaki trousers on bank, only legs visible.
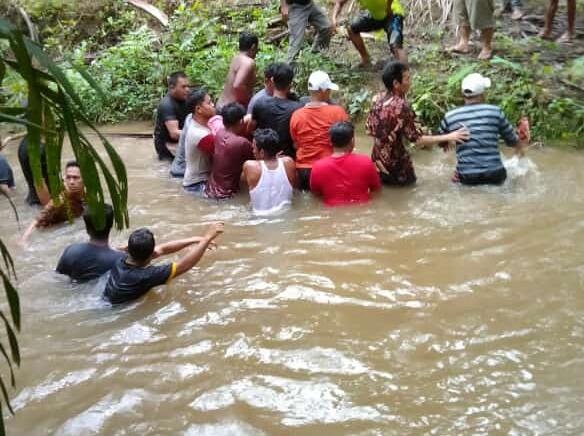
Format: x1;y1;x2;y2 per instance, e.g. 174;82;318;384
450;0;495;60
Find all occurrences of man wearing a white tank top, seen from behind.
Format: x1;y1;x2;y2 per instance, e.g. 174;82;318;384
243;129;296;215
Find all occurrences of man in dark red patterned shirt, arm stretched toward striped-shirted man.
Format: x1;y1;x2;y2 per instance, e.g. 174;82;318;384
365;62;468;186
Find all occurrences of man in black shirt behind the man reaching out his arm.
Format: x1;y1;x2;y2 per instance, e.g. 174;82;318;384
57;204;126;282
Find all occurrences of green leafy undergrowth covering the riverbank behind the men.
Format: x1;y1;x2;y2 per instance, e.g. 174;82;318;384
3;0;584;146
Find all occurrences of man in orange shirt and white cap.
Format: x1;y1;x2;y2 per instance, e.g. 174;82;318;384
290;71;349;191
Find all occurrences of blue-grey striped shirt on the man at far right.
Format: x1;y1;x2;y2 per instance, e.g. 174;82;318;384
440;103;519;175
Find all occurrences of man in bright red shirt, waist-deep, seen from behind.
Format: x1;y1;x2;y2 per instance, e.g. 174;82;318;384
310;121;381;206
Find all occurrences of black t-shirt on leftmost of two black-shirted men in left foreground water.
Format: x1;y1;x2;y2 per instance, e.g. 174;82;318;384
57;242;126;282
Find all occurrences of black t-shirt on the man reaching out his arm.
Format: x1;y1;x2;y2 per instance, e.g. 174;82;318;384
103;257;176;304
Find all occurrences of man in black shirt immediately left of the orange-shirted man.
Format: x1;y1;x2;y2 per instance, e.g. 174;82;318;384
252;63;302;158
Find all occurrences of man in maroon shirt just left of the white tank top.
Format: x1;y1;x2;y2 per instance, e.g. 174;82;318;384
205;103;254;199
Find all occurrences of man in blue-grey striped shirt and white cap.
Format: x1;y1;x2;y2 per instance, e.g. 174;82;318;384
440;73;530;185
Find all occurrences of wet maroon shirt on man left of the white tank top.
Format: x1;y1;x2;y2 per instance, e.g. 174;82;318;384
205;129;254;198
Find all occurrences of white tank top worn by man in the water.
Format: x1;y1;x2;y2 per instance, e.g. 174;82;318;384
249;158;294;215
